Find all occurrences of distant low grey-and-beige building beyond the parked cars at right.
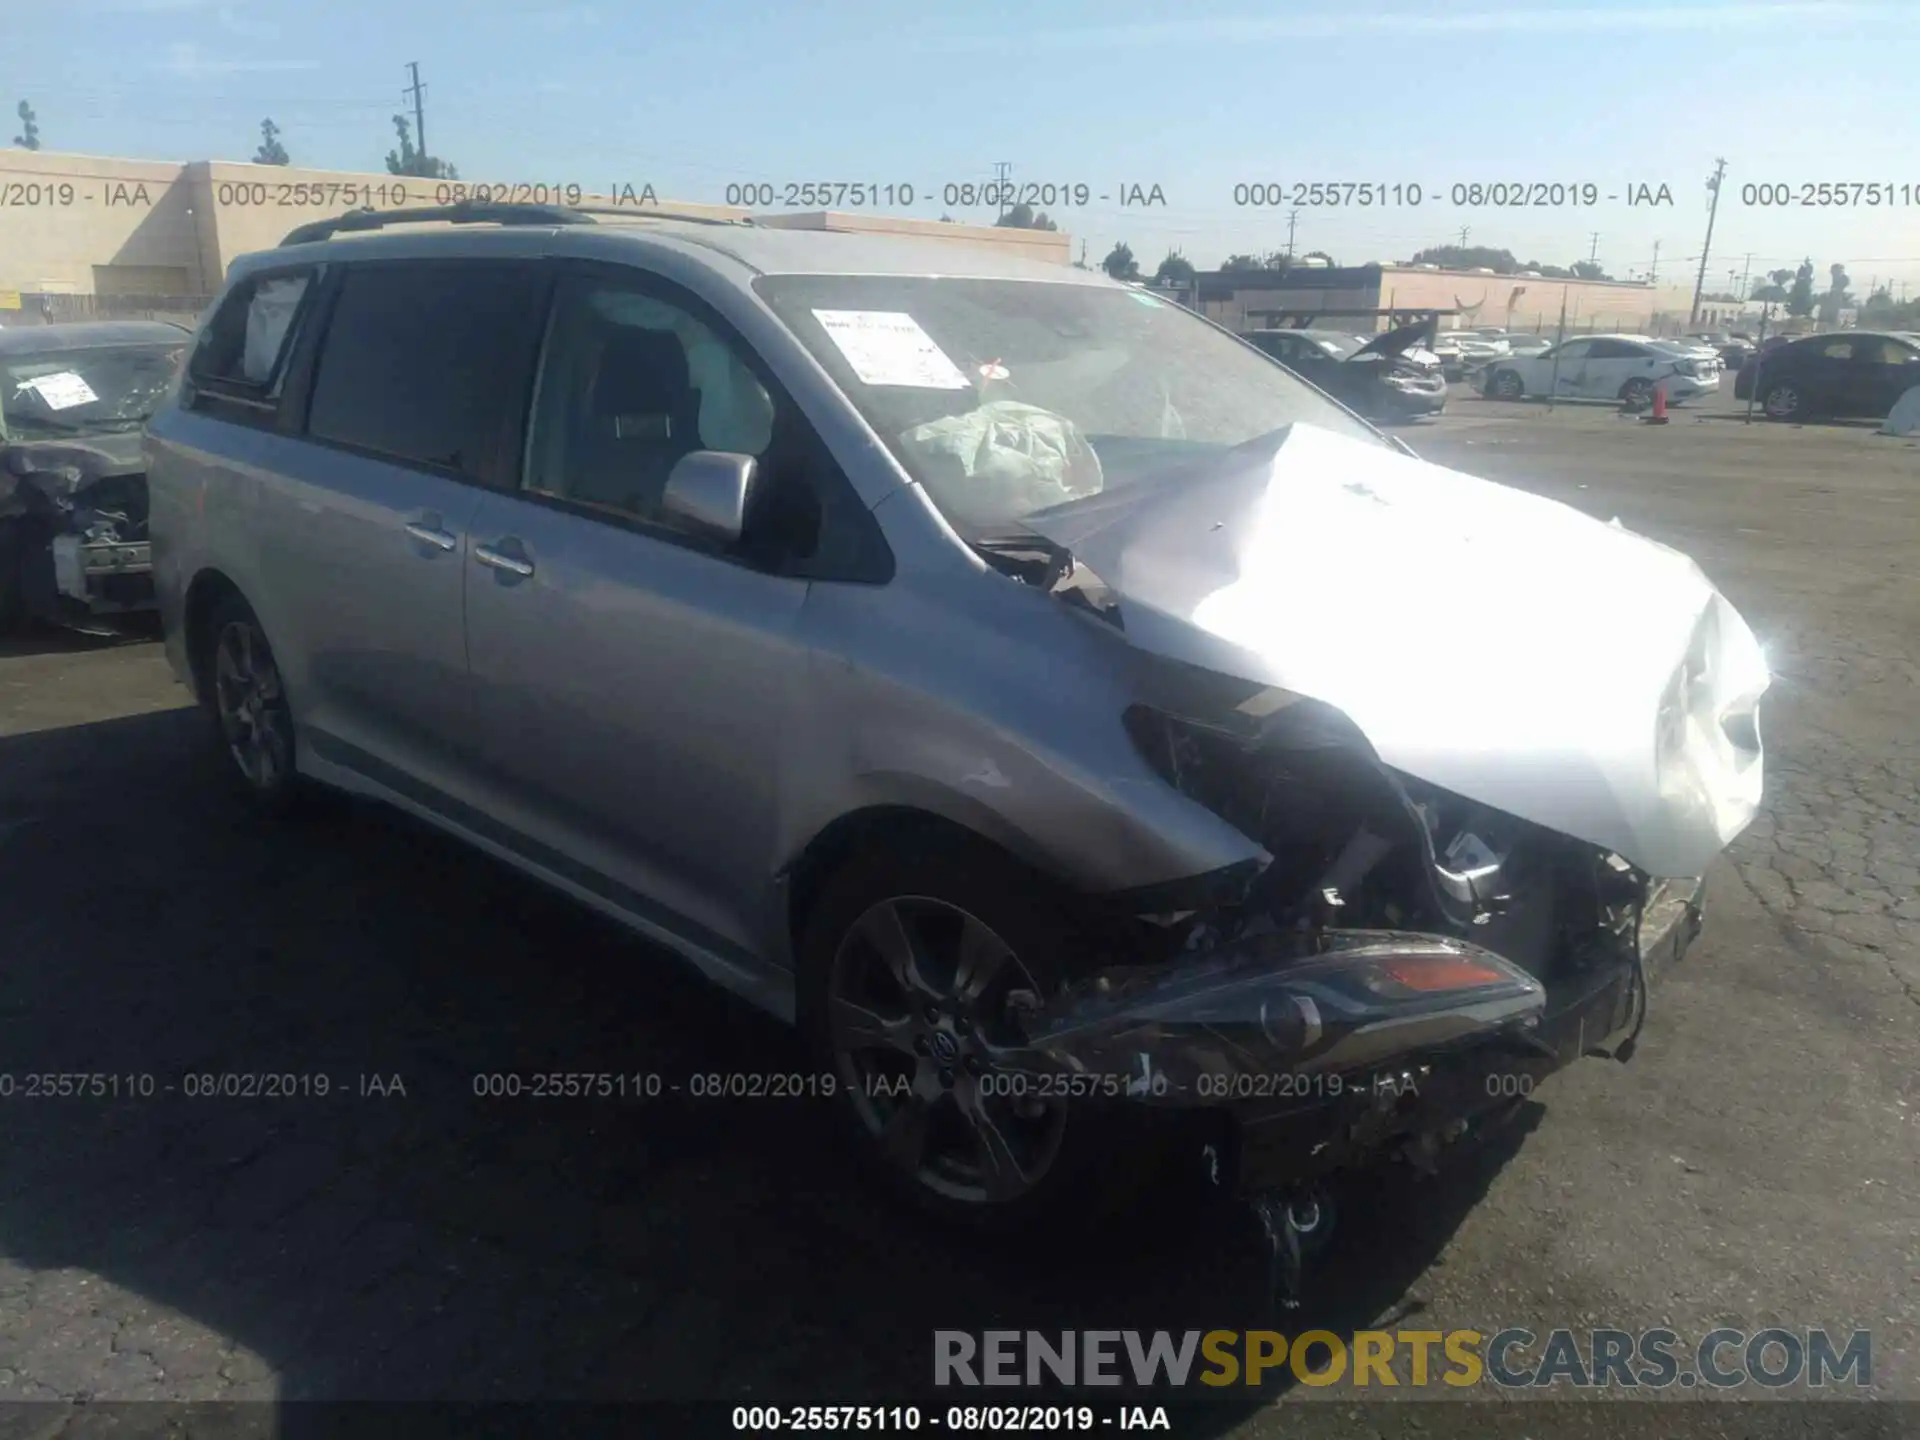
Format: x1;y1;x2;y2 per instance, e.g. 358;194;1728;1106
1198;265;1705;334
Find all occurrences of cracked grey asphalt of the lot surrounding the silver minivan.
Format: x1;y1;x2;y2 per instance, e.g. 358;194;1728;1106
0;385;1920;1436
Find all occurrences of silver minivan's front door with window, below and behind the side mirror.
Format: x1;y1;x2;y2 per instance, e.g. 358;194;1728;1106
467;267;825;960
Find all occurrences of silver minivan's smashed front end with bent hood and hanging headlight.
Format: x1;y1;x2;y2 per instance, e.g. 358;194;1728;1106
995;426;1768;1292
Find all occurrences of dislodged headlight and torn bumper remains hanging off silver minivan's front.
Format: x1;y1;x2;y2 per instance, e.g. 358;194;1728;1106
1002;879;1703;1192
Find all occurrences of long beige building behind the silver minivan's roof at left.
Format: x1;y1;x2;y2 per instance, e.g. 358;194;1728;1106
0;150;1071;324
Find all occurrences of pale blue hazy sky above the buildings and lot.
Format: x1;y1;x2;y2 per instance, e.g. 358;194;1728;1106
11;0;1920;294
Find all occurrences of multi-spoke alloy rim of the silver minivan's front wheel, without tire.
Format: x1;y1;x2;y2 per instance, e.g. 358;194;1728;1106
828;897;1066;1206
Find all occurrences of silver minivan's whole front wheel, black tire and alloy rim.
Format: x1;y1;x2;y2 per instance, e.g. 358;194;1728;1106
799;833;1152;1233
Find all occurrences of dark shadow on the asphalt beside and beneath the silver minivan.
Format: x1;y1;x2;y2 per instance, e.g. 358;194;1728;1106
0;710;1526;1434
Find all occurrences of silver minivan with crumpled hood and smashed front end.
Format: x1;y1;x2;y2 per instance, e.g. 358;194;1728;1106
148;207;1766;1282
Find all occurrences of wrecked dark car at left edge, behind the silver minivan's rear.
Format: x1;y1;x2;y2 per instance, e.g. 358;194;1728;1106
0;321;192;626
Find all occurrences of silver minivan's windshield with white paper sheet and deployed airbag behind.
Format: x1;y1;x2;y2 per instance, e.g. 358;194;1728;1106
755;275;1386;532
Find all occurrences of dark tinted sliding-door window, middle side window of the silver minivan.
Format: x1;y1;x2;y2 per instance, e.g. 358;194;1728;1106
307;261;538;482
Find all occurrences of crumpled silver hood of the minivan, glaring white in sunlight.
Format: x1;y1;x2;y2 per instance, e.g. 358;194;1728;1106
1027;424;1770;876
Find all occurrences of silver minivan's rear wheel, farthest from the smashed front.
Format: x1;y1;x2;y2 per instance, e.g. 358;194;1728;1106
202;595;305;814
